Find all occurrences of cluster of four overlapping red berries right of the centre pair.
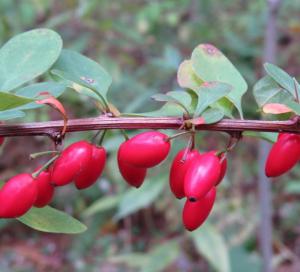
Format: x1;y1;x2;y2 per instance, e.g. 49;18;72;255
169;149;227;231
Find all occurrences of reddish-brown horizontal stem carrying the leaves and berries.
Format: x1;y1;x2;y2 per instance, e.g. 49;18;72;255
0;117;300;138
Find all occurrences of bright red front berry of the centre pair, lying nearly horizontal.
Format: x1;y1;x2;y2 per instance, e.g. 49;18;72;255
121;131;171;168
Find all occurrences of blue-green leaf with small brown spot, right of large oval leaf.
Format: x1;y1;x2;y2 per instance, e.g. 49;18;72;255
52;49;112;101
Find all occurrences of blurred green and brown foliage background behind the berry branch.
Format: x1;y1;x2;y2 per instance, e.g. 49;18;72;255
0;0;300;272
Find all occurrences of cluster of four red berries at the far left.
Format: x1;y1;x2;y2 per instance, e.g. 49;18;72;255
0;141;106;218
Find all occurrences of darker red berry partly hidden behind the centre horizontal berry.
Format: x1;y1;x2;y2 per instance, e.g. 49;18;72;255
118;142;147;188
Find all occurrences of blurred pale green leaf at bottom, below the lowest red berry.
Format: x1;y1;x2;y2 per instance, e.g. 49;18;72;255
190;223;231;272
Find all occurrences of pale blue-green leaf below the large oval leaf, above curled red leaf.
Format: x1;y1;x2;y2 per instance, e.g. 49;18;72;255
15;81;67;110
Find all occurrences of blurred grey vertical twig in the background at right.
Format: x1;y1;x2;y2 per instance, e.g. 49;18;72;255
258;0;281;272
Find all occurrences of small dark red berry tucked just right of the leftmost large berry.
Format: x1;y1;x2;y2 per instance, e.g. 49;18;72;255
33;167;54;208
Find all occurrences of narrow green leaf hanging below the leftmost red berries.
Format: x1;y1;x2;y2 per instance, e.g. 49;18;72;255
17;206;87;234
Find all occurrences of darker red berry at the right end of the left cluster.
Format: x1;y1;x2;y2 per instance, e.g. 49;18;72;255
75;145;106;190
